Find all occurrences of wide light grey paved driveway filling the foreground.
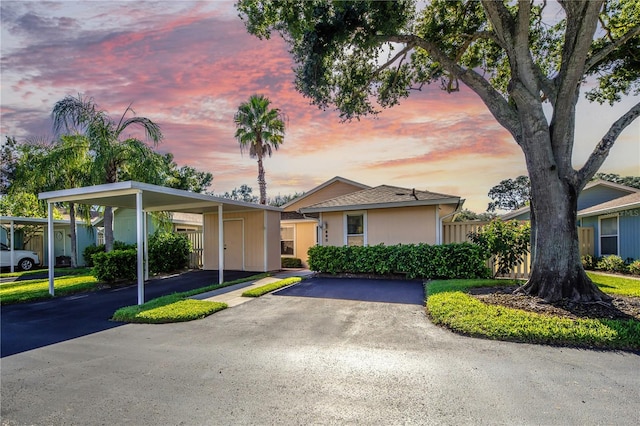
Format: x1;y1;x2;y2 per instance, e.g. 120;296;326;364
1;280;640;425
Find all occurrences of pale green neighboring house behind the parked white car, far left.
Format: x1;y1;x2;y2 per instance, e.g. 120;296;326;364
0;216;96;266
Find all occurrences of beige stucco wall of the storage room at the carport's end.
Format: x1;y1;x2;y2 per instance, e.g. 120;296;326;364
203;210;280;271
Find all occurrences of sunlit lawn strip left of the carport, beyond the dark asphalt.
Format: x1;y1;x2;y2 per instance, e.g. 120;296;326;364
0;271;98;305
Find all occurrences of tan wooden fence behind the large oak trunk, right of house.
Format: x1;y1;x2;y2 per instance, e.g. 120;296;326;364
442;222;594;279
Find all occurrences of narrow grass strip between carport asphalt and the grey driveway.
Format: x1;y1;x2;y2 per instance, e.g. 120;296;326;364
111;273;269;324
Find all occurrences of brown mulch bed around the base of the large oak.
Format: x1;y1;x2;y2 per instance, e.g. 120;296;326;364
469;286;640;321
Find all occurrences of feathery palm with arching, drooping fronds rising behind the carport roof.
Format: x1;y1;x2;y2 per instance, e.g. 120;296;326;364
51;95;162;251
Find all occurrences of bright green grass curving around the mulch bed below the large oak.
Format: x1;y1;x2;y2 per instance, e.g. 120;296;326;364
425;277;640;350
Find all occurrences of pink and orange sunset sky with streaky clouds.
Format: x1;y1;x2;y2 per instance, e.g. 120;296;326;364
0;0;640;212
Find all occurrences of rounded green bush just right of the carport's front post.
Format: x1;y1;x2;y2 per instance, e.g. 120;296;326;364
149;231;191;273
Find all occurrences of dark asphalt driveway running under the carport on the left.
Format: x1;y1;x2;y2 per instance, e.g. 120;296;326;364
0;271;256;357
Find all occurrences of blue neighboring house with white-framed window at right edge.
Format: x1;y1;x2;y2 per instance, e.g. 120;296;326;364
578;191;640;259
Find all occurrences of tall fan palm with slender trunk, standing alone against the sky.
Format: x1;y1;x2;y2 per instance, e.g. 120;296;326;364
234;95;286;204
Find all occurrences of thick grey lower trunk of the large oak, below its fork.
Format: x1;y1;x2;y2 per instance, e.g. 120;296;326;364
519;169;611;302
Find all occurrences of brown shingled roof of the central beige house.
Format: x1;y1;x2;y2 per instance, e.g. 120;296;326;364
300;185;460;213
